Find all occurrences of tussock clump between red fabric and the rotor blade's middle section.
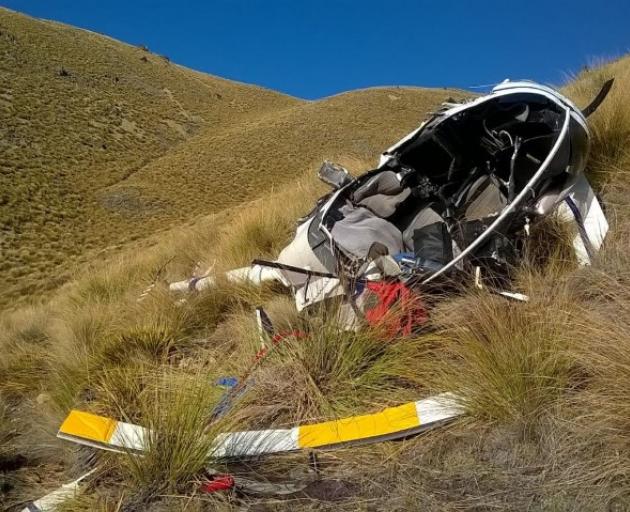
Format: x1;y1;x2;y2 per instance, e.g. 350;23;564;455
241;319;430;425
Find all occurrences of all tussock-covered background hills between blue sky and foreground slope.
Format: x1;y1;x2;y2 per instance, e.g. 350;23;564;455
0;9;456;305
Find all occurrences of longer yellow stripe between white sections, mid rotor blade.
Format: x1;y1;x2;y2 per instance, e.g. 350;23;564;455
298;402;420;448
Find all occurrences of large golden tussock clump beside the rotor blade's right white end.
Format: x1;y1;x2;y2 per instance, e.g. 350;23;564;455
435;281;576;429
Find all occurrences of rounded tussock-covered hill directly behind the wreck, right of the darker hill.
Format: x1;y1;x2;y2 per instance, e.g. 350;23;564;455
108;89;448;227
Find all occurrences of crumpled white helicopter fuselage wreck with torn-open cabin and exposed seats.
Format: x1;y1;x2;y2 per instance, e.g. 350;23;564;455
170;81;612;334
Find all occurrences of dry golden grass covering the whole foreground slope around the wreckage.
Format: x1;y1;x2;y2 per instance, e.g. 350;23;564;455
0;20;630;511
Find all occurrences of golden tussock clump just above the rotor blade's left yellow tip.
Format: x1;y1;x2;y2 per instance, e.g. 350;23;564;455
50;303;192;414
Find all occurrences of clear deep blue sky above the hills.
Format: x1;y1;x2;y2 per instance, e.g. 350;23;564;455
0;0;630;99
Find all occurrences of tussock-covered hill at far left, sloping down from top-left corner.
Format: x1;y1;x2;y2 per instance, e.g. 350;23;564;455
0;9;298;304
